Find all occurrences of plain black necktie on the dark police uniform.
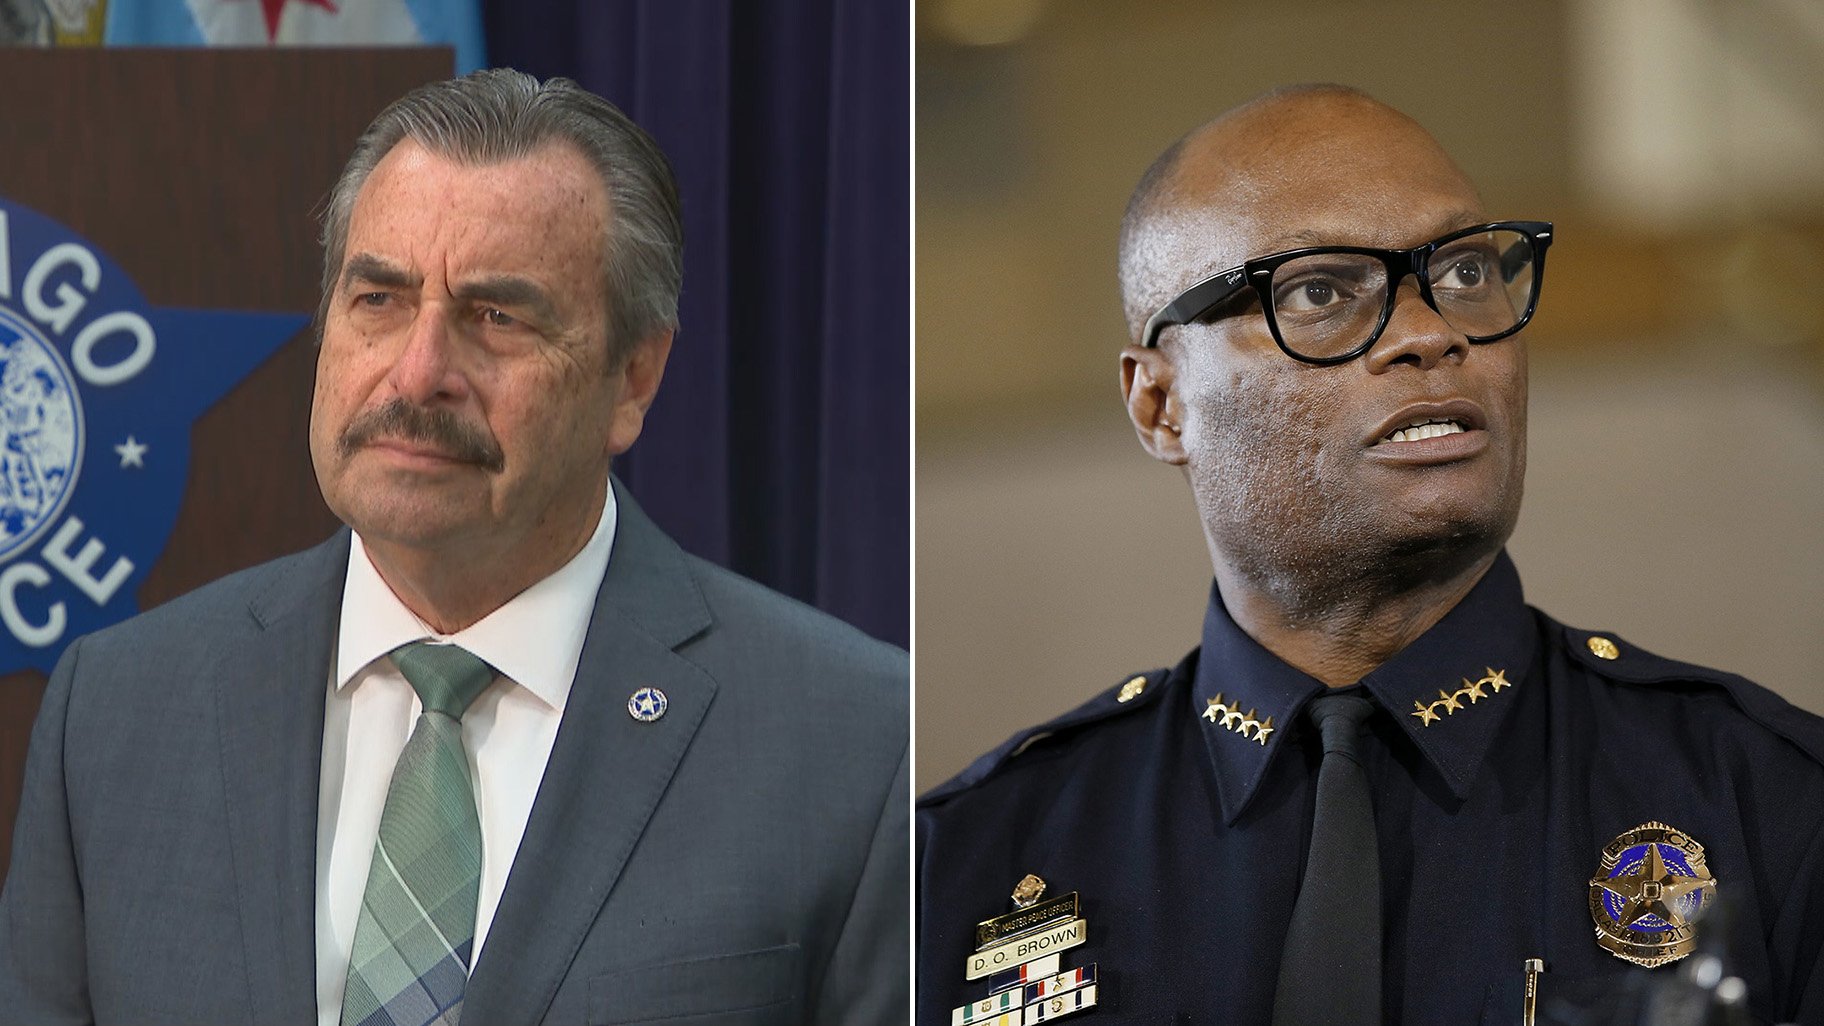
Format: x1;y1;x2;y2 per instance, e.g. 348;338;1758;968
1273;694;1381;1026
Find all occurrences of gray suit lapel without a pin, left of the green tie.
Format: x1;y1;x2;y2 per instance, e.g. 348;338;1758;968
215;531;348;1022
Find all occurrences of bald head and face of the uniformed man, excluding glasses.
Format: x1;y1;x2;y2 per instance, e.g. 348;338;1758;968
1120;86;1527;638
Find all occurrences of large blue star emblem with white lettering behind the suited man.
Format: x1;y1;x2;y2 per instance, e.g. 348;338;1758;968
0;198;310;675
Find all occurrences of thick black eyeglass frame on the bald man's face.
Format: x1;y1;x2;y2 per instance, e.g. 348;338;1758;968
1140;221;1552;363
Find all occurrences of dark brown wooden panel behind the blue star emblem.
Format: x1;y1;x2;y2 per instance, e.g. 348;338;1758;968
0;47;454;876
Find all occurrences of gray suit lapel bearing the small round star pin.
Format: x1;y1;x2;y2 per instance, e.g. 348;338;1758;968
463;480;715;1022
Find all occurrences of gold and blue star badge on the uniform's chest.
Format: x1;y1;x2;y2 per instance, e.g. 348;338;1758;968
1591;822;1716;969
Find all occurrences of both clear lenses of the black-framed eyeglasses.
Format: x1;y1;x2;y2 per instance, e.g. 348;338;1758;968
1270;228;1538;360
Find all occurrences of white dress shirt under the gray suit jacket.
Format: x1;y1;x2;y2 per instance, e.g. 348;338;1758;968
316;489;615;1026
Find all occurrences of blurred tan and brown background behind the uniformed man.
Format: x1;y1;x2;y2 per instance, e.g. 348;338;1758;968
916;0;1824;790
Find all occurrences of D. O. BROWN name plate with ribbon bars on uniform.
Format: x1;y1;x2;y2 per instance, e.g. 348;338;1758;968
950;874;1096;1026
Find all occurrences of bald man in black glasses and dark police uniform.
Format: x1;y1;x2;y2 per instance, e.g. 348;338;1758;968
917;86;1824;1026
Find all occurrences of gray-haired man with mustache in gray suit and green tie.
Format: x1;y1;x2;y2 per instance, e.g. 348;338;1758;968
0;71;908;1026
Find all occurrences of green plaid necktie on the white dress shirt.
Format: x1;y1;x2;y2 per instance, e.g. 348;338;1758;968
341;641;494;1026
